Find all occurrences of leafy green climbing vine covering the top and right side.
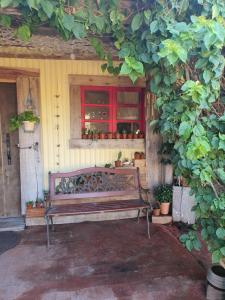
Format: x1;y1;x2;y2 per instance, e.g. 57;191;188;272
0;0;225;262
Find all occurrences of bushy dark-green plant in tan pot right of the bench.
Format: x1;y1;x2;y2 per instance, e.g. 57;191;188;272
153;184;173;215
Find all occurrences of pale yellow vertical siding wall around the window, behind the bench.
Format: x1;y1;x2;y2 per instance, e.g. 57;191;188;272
0;58;143;188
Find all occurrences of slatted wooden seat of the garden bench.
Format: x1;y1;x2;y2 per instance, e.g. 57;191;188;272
46;199;149;217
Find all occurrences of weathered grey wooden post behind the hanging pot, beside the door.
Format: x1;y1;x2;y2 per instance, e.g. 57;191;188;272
16;76;43;214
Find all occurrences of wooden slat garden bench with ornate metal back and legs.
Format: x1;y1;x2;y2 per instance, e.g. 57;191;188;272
45;167;151;246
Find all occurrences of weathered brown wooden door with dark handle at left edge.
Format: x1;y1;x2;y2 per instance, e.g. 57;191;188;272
0;83;21;216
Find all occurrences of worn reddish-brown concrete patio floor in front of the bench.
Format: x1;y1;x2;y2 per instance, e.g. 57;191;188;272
0;220;206;300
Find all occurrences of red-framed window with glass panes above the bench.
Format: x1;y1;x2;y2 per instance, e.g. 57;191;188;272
80;86;144;133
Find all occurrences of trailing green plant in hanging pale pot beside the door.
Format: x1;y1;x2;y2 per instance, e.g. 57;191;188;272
9;110;40;132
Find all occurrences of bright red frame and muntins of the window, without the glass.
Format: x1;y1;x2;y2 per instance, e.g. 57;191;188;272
80;86;145;132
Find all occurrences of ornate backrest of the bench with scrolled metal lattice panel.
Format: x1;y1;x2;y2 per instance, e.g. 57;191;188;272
49;167;140;201
